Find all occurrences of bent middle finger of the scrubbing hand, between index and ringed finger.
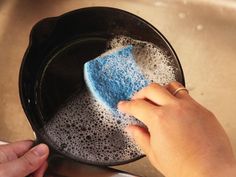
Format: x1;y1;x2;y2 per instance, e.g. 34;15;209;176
132;83;175;105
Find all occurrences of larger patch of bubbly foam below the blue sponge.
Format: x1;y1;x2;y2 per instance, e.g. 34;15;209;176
44;90;142;164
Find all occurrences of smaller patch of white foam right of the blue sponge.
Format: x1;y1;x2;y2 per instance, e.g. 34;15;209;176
108;36;177;85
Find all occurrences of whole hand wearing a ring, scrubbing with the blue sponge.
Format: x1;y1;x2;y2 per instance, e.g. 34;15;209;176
118;82;236;177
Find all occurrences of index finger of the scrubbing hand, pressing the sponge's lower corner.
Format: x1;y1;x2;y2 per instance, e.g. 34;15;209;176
118;99;158;128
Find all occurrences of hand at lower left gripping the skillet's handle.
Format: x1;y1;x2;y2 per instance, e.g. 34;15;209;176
0;141;49;177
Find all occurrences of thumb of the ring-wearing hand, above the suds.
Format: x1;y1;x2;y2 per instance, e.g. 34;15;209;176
125;125;150;155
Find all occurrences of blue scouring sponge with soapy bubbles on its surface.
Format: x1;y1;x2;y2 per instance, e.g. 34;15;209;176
84;45;149;112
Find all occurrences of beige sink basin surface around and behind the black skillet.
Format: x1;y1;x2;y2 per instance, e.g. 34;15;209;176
0;0;236;177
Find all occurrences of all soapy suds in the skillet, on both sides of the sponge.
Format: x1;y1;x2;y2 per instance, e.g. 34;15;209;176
44;36;176;165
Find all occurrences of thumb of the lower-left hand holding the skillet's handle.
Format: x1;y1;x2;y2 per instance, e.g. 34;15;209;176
2;144;49;177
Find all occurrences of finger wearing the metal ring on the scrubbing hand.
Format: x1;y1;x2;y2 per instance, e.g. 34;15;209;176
165;81;190;98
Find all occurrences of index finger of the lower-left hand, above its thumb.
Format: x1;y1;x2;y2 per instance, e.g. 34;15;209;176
0;140;33;163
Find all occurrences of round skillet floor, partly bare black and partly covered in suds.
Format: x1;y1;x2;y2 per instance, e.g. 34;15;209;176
38;36;179;165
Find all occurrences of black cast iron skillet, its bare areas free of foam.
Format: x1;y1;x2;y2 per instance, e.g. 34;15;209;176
19;7;184;165
